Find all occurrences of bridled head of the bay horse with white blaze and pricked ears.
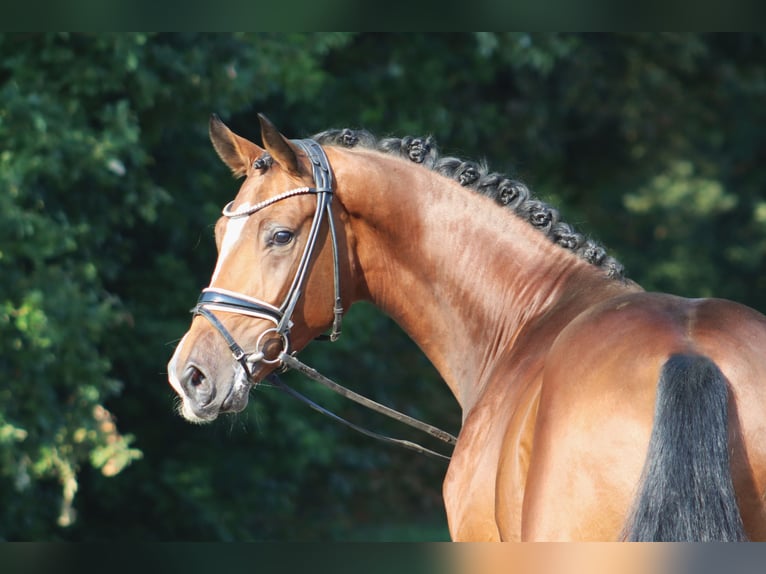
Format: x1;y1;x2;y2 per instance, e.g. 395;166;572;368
168;116;345;422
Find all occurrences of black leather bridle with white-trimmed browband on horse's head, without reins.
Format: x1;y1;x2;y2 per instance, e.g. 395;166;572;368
191;139;343;378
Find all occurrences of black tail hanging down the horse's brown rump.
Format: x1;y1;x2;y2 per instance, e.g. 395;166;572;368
625;355;747;542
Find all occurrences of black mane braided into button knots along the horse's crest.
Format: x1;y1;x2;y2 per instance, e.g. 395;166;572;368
312;128;625;280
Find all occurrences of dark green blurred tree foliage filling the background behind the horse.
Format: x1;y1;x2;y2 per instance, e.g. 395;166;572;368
0;33;766;540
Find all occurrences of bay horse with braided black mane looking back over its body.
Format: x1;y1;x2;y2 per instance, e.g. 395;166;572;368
168;116;766;541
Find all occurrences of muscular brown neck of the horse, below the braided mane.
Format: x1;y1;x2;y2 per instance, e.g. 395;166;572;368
338;148;636;409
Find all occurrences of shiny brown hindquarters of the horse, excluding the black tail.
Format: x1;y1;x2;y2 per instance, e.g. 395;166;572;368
522;293;766;540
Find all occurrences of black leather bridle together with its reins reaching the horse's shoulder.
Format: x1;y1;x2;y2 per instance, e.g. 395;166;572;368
191;139;457;460
